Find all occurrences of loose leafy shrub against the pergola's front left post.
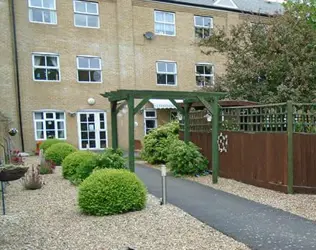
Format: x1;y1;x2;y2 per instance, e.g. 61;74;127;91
97;148;126;169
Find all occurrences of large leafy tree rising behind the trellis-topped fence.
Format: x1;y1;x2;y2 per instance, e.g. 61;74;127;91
200;0;316;103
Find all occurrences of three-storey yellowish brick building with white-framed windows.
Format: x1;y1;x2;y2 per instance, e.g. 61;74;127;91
0;0;282;154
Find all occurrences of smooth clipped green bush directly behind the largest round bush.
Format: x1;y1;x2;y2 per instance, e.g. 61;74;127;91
62;151;97;183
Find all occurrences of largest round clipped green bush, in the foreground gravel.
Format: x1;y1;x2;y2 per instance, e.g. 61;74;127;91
78;169;147;216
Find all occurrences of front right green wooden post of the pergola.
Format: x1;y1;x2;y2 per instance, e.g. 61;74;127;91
212;97;219;184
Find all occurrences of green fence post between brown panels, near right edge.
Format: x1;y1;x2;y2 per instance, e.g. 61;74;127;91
287;101;293;194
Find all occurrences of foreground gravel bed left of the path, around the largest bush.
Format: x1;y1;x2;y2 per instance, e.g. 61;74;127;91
0;158;249;250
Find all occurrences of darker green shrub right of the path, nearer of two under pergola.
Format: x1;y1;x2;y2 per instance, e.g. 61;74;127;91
167;140;208;175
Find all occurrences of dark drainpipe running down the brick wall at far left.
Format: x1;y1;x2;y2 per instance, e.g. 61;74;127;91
10;0;24;152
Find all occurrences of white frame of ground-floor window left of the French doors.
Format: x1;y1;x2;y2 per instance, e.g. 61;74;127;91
33;110;67;141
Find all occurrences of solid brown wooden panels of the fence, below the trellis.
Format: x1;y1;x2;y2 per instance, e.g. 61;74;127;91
180;131;316;193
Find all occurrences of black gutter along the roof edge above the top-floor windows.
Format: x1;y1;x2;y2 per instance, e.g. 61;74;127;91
151;0;274;17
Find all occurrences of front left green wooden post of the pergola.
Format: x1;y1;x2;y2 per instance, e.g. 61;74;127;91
127;96;135;172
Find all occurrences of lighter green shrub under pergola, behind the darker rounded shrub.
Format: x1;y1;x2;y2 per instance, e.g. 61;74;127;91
141;122;179;164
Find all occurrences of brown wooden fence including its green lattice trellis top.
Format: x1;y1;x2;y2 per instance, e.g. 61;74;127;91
180;100;316;193
